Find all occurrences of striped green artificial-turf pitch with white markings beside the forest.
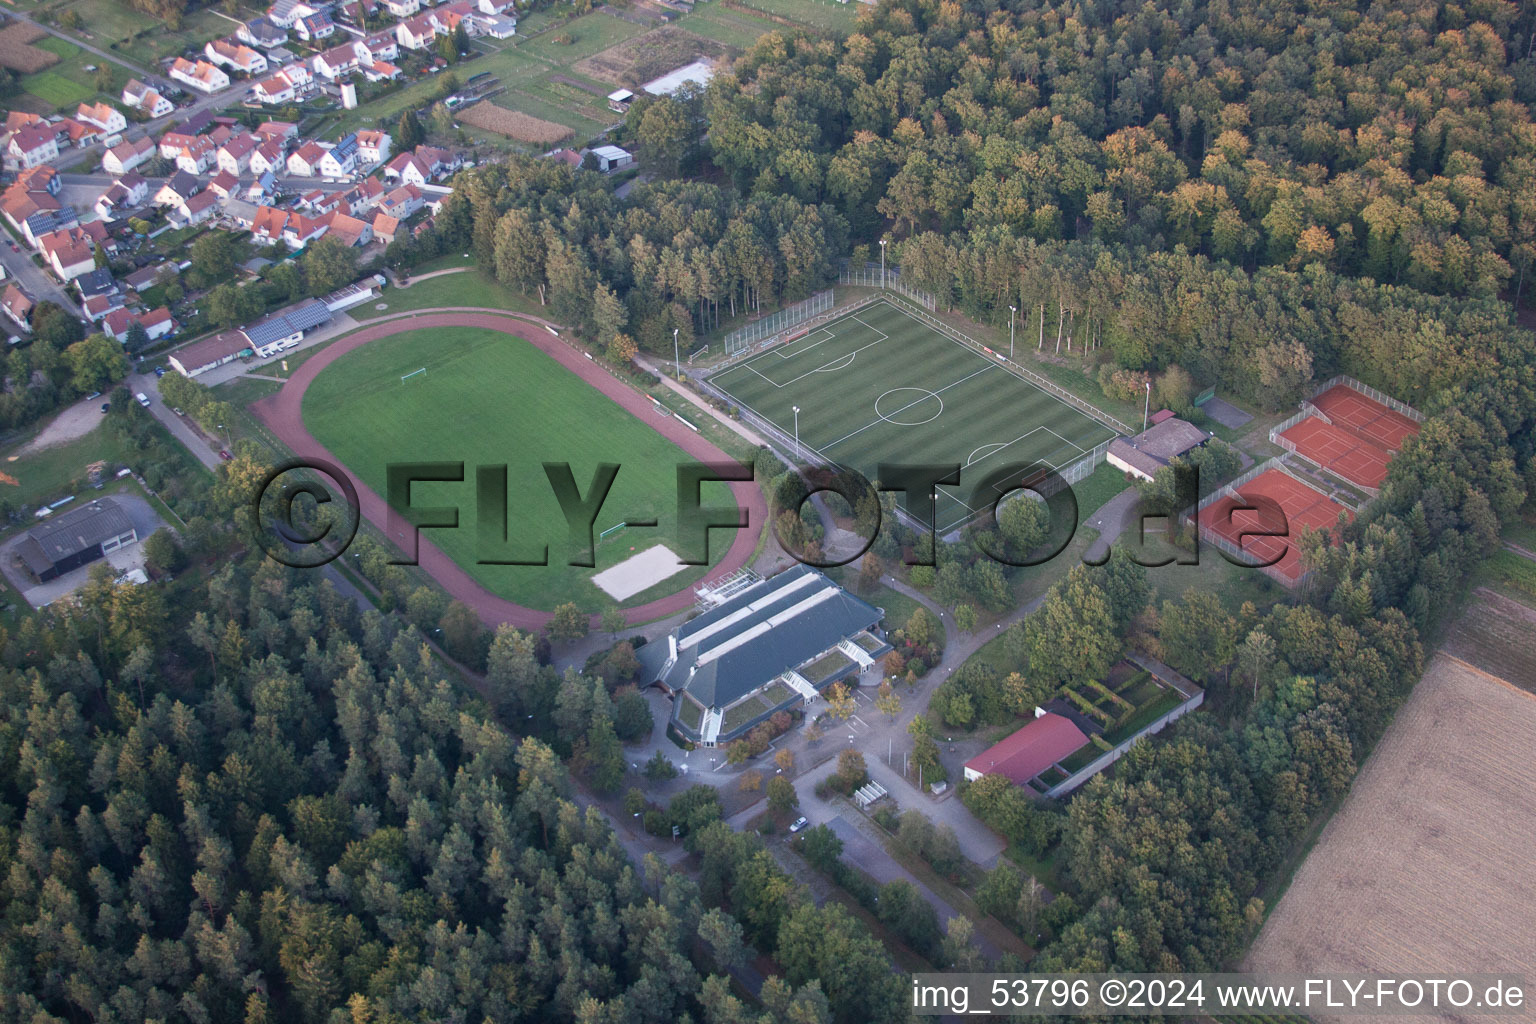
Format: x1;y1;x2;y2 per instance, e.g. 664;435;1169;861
710;299;1115;533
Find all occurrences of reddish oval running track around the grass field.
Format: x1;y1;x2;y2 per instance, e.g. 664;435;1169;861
250;310;768;629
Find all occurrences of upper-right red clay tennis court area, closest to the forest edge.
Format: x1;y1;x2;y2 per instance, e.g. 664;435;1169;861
1279;384;1419;488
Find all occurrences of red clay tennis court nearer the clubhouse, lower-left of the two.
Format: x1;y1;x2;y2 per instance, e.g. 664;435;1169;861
1200;470;1355;583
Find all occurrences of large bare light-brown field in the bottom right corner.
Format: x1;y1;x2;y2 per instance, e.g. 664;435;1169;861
1243;652;1536;1021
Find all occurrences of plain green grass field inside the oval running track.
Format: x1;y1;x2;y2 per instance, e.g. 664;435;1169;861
303;327;733;611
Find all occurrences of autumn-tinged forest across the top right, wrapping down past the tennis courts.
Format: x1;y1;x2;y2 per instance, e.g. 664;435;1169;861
395;0;1536;970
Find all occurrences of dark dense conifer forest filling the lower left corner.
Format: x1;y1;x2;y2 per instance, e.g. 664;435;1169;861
0;540;905;1024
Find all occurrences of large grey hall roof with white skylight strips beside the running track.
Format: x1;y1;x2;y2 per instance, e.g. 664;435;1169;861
647;565;882;708
